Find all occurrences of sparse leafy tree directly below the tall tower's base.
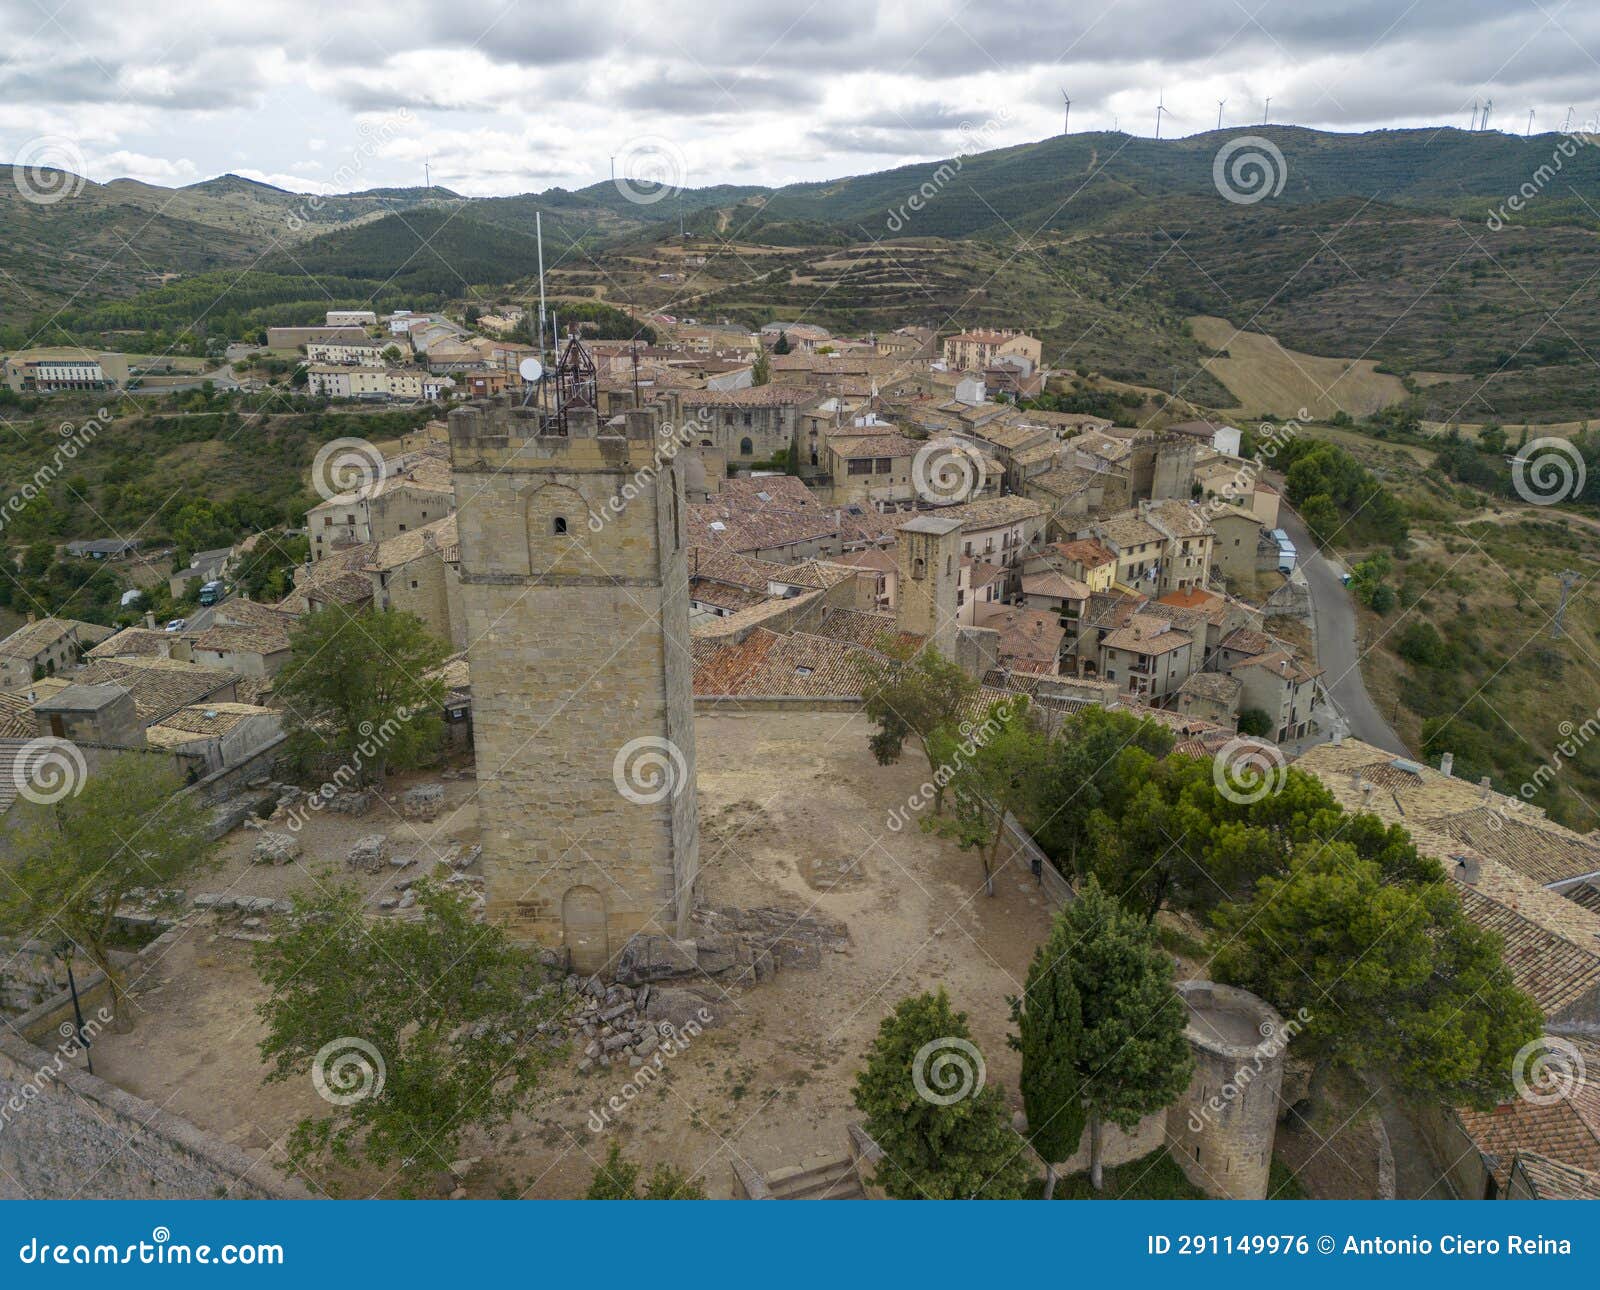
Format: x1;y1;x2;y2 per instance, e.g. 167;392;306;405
256;880;565;1196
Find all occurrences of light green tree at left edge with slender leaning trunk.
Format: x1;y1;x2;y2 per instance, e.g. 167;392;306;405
0;758;213;1023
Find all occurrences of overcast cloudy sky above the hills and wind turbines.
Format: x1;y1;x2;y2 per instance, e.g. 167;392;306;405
0;0;1600;195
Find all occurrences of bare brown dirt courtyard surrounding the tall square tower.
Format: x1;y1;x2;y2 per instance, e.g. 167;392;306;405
94;712;1050;1197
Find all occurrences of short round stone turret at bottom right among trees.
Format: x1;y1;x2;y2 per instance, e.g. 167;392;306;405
1166;981;1291;1200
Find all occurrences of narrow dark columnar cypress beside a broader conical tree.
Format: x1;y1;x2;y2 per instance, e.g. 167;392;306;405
1010;914;1088;1200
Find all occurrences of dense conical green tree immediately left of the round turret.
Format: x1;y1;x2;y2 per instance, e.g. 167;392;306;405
1059;879;1194;1191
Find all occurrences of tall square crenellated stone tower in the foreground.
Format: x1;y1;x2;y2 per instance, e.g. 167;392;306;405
450;400;699;973
